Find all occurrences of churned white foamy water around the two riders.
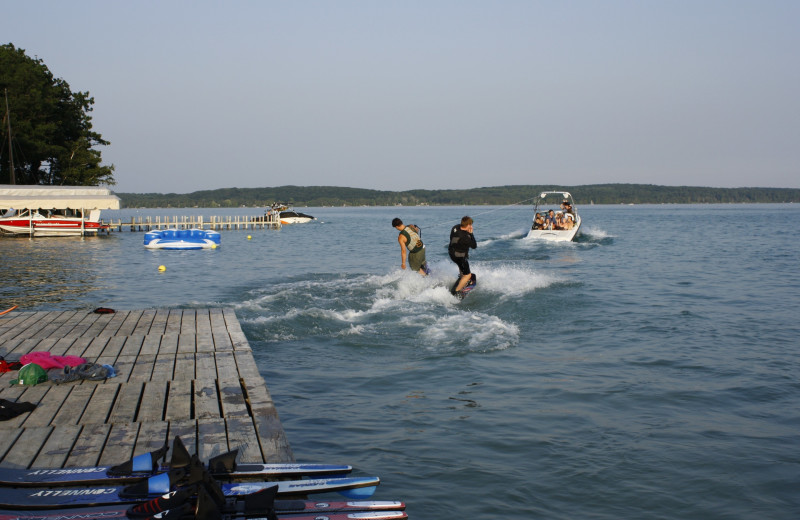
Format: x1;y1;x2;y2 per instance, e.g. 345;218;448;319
237;261;562;357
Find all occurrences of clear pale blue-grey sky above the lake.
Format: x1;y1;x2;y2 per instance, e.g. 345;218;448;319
0;0;800;193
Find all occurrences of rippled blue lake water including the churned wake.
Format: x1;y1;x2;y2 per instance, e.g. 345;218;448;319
0;201;800;520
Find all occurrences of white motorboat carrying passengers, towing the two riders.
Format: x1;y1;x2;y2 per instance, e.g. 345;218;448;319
526;191;581;242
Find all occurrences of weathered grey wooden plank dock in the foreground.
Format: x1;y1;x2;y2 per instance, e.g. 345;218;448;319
0;309;294;468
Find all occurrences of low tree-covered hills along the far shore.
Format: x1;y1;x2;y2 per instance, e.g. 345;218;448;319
117;184;800;208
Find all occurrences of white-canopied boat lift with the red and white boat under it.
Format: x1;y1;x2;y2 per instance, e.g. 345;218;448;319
0;185;120;236
